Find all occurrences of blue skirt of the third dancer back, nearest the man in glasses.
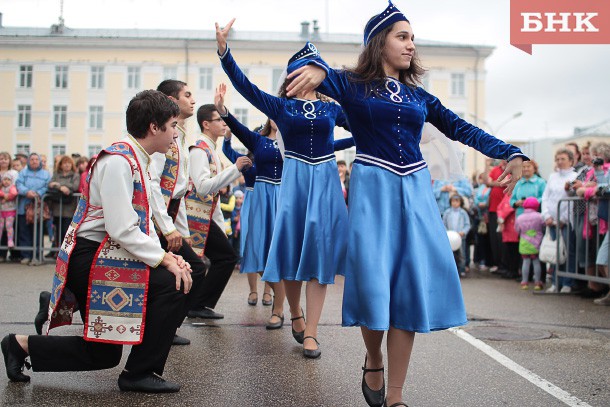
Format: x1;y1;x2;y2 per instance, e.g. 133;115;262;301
241;181;280;273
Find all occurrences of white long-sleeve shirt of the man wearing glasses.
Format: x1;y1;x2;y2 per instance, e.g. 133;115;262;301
189;134;241;230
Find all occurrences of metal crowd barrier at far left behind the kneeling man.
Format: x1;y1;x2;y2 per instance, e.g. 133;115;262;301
0;193;80;265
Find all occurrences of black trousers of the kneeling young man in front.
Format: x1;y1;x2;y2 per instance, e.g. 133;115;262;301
28;238;188;375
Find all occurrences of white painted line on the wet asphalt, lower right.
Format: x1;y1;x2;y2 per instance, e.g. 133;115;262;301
449;328;591;407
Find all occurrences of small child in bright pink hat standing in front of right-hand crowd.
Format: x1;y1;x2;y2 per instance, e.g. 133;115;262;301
515;196;544;291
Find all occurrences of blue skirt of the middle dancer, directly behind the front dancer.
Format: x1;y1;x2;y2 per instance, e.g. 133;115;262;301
262;157;347;284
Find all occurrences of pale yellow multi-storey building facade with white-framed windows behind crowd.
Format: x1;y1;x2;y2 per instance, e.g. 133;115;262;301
0;20;493;176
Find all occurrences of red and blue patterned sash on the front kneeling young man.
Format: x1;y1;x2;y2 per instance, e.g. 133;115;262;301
47;142;150;345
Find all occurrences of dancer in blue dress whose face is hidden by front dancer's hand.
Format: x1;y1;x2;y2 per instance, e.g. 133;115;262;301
216;20;354;358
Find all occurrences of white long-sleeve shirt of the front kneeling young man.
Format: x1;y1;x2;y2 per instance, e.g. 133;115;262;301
76;137;165;267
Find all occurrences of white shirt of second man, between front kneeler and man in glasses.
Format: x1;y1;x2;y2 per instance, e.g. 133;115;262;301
151;126;190;238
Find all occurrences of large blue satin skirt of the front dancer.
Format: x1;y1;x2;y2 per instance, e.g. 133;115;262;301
343;164;467;332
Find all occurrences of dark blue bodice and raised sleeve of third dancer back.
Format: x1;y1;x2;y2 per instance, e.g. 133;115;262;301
221;112;284;184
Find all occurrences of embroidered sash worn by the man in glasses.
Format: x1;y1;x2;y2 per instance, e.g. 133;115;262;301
184;140;218;257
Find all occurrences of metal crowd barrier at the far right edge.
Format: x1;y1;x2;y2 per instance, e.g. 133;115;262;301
553;197;610;288
